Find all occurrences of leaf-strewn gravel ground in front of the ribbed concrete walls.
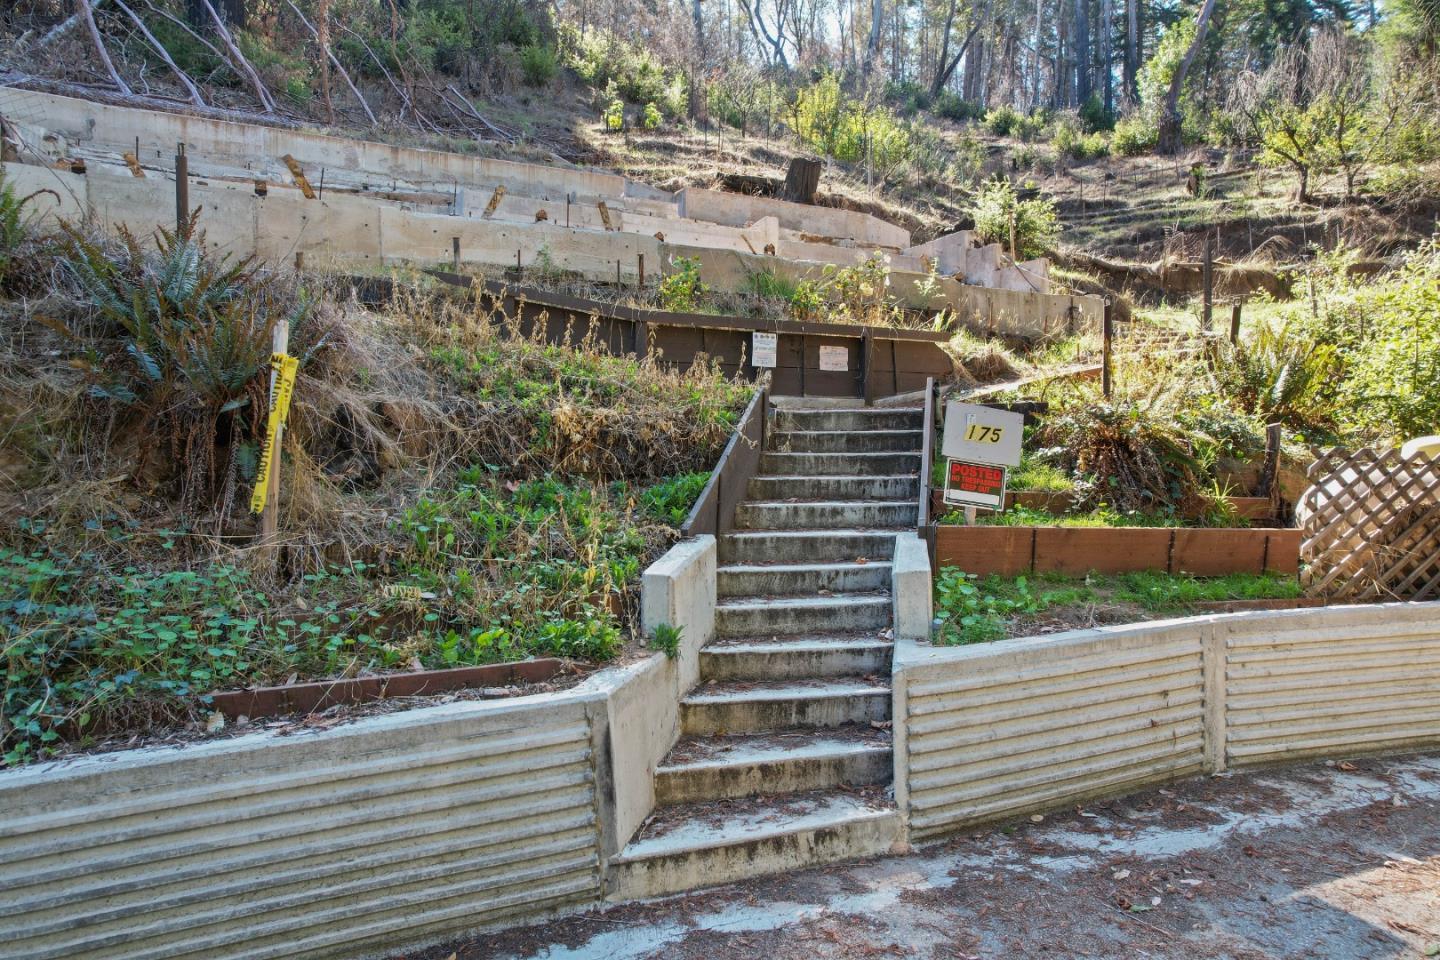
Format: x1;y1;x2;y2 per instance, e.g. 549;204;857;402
396;756;1440;960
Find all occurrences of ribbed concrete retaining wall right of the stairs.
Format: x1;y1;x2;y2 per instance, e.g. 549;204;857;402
894;603;1440;838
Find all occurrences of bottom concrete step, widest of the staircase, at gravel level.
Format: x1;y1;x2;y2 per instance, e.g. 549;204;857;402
606;790;900;901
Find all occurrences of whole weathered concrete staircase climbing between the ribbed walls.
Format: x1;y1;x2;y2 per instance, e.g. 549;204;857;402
609;407;922;900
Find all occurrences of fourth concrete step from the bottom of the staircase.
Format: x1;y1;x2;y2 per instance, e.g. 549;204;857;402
700;632;894;682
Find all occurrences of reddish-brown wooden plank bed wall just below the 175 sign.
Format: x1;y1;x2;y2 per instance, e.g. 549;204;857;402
935;525;1300;577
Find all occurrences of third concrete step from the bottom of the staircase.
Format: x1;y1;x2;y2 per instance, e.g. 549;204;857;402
680;679;890;737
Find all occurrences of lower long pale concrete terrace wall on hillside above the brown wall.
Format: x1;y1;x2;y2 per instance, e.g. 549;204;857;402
4;163;1103;337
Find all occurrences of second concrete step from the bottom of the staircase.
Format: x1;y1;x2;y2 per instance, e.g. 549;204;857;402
655;727;894;806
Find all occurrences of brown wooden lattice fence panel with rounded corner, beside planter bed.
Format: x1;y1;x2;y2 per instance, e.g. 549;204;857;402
1296;448;1440;600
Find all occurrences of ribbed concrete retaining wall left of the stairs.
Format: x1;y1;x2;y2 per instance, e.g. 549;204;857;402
0;692;605;960
